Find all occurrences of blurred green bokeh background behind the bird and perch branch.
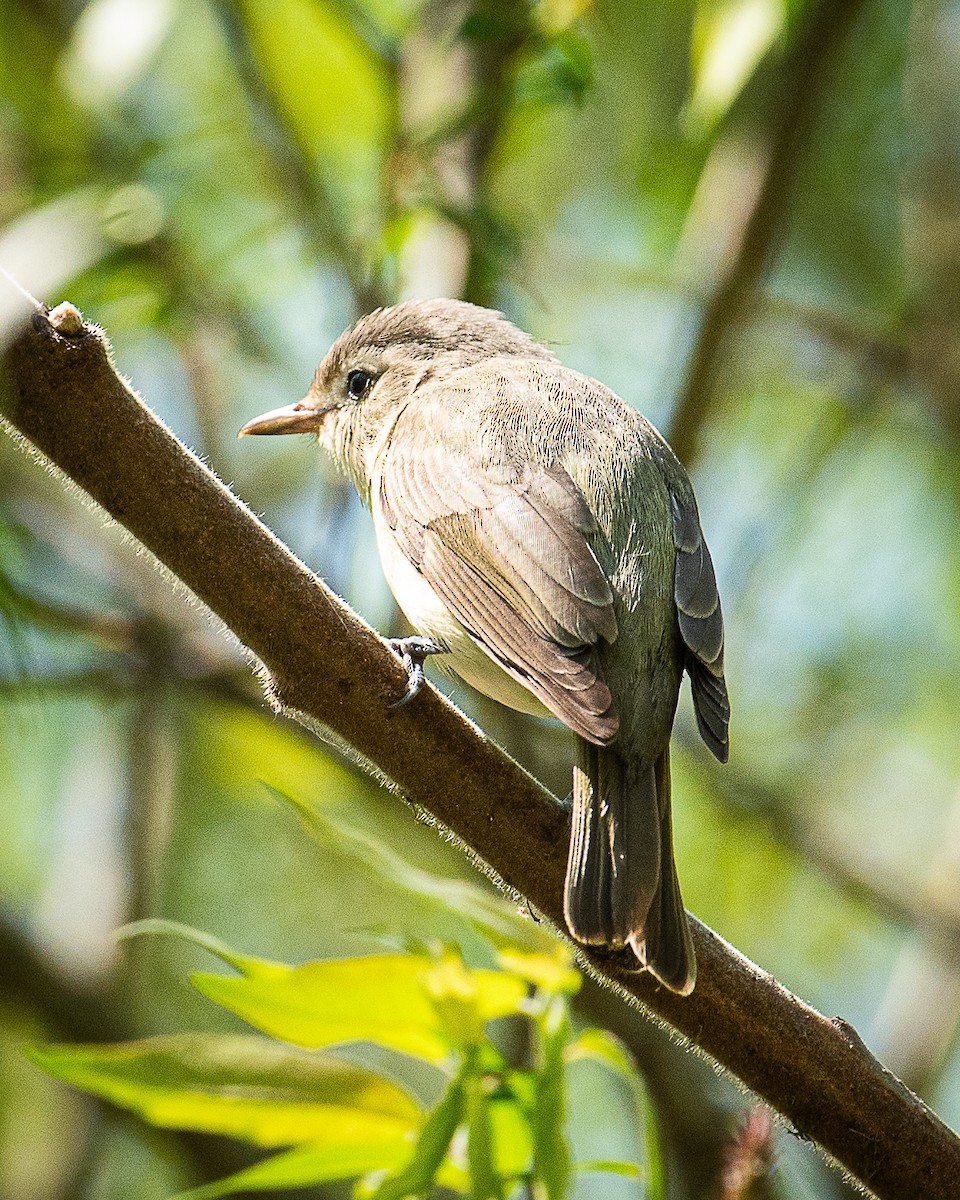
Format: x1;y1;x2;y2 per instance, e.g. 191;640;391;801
0;0;960;1200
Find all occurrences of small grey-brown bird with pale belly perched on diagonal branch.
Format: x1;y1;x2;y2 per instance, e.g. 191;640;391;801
240;299;730;995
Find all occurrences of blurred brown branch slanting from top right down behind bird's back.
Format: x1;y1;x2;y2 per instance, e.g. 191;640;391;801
665;0;864;463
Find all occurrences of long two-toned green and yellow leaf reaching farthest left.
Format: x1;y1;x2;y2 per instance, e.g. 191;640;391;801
30;1033;421;1146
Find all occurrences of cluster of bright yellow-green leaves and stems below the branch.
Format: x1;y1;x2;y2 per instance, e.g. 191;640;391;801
30;902;655;1200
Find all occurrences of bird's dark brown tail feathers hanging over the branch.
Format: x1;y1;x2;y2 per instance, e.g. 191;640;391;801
564;738;696;995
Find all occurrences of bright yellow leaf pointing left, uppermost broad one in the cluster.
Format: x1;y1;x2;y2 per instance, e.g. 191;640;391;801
193;954;453;1063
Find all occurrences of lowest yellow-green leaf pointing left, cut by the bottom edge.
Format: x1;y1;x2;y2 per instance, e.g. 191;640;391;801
176;1128;410;1200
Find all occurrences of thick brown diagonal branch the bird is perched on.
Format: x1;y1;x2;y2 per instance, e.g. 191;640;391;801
2;306;960;1200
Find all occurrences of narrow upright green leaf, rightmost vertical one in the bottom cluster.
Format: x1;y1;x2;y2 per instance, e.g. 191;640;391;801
530;996;570;1200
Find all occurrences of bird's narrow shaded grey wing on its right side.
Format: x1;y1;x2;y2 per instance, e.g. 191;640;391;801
670;476;730;762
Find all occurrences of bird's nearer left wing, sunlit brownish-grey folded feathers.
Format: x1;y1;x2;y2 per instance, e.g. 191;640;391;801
379;409;618;744
